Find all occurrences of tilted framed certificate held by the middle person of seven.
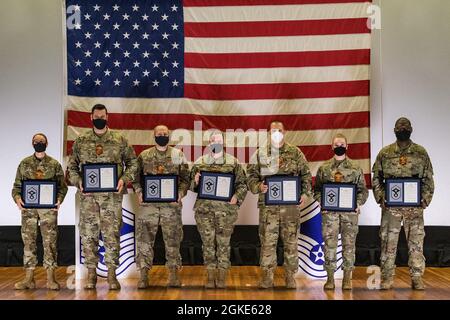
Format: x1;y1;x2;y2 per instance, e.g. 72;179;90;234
198;171;235;201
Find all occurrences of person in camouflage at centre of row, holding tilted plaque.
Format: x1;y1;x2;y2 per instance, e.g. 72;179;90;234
191;131;247;288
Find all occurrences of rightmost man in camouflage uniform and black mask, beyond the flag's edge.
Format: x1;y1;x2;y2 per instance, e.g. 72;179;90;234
372;118;434;290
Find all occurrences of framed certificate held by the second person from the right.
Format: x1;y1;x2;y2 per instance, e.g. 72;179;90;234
321;183;357;212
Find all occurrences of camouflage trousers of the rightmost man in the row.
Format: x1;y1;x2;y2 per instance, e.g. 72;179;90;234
380;208;425;278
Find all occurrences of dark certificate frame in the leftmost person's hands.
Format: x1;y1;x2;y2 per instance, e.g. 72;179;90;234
20;179;58;209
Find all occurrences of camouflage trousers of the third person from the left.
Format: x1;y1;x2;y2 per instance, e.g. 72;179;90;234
136;204;183;269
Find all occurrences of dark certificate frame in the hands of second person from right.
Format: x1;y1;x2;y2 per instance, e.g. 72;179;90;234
320;182;358;212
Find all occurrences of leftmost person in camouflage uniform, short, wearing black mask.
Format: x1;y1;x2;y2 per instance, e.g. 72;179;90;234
12;133;67;290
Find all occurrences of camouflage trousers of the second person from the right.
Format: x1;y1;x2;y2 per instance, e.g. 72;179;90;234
322;211;358;272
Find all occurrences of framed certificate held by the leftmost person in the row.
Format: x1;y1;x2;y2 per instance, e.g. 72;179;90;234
22;180;57;209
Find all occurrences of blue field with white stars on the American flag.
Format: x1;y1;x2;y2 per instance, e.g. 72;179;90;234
66;0;184;98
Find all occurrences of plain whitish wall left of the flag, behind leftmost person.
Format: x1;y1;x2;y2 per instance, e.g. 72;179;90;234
0;0;74;225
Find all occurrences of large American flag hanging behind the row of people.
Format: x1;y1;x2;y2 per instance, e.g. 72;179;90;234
65;0;371;181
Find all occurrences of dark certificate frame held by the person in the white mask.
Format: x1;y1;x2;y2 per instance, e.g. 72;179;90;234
264;175;301;206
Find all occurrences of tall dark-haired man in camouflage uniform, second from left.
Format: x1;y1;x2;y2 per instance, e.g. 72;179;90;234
68;105;137;290
